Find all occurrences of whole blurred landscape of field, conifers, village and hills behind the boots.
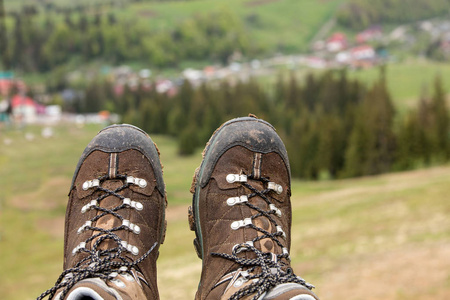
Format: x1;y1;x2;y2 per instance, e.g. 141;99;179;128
0;0;450;300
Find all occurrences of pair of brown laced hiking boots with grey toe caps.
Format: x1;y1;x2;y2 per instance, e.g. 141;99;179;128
38;116;318;300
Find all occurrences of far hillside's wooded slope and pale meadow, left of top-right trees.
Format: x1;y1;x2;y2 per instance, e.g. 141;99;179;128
0;0;341;74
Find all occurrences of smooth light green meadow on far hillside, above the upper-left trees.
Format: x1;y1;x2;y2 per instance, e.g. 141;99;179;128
5;0;343;53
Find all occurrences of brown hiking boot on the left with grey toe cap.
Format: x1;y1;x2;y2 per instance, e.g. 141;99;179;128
38;125;167;300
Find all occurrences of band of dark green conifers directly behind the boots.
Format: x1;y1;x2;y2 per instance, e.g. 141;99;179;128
72;71;450;179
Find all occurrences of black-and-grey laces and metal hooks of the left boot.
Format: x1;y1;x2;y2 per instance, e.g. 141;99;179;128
37;175;158;300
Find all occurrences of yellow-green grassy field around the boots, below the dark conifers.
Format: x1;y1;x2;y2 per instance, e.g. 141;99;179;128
0;125;450;300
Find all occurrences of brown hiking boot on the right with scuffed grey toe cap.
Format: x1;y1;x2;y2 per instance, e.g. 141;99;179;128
189;117;318;300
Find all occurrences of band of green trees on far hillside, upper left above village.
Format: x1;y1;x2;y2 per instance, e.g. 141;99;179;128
0;6;253;72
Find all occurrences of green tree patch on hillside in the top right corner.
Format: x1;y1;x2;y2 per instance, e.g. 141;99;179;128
337;0;450;30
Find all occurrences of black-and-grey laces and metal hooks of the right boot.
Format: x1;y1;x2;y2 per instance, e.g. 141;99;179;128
211;174;314;300
